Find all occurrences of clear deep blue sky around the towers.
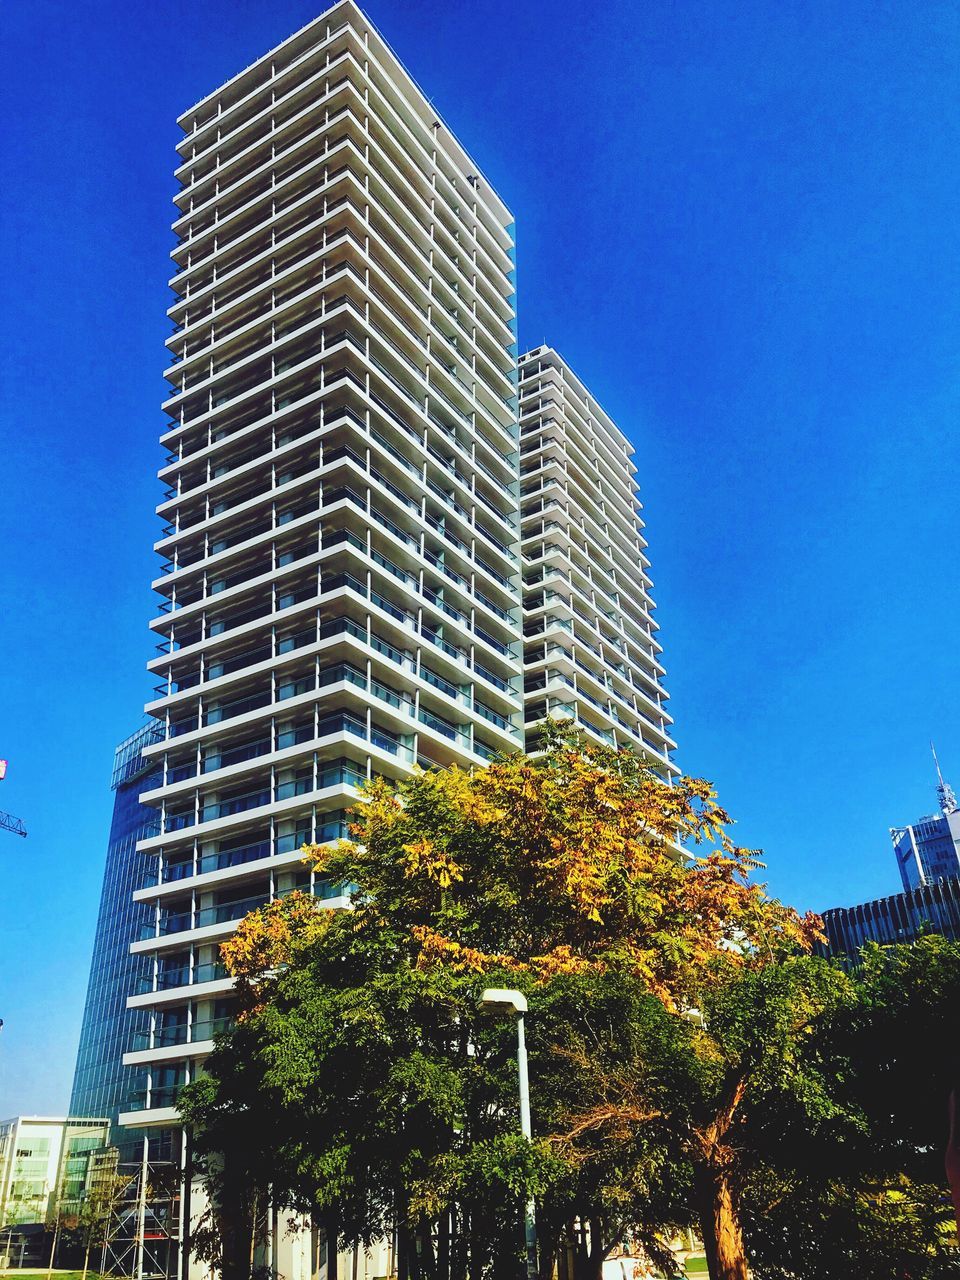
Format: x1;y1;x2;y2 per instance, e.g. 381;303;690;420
0;0;960;1115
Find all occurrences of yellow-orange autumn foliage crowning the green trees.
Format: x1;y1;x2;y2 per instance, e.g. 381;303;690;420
224;730;819;1007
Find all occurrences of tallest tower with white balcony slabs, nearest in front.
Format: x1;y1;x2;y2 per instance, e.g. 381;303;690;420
122;0;521;1126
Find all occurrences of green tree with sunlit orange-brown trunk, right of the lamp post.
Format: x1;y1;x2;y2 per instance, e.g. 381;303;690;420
545;954;860;1280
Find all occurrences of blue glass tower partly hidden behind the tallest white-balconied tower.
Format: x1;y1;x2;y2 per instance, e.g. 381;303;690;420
70;721;161;1147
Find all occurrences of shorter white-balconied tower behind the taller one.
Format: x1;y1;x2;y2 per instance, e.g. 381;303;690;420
520;347;680;777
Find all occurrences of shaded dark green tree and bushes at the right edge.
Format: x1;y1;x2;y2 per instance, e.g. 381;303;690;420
727;936;960;1280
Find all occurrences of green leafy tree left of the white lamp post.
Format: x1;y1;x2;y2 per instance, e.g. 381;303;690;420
184;900;555;1277
